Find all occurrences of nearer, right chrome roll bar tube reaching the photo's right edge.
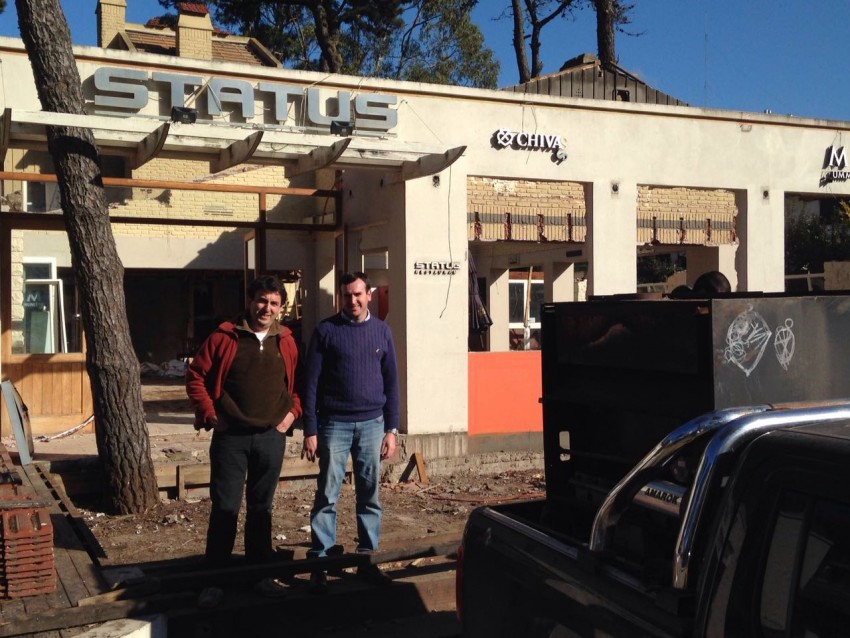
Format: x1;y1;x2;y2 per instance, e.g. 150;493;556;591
673;401;850;589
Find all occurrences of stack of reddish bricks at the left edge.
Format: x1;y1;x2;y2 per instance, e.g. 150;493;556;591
0;444;56;598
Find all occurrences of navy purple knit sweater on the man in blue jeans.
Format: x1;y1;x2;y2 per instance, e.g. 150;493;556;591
301;313;399;436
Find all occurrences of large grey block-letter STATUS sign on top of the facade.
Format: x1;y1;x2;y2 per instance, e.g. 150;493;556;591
94;67;398;132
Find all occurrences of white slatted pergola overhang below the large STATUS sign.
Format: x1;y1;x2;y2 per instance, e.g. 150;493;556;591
0;109;466;181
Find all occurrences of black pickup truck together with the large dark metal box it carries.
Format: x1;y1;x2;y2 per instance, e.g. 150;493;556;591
457;296;850;638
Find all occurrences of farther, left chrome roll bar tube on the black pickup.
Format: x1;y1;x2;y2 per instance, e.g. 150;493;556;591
590;405;770;552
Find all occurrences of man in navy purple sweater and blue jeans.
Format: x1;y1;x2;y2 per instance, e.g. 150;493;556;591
301;272;399;592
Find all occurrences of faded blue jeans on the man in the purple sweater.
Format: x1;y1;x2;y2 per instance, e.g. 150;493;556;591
307;417;384;556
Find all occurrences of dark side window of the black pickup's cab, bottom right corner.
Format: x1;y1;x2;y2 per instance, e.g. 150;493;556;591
760;492;850;638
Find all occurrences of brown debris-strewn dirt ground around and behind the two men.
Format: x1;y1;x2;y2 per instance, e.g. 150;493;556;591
71;381;545;565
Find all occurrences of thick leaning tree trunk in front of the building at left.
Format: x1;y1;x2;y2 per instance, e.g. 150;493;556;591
15;0;158;514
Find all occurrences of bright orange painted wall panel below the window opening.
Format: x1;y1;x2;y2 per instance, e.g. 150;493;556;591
469;350;543;436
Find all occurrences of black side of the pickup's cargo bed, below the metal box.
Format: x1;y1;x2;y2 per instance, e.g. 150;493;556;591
459;500;691;636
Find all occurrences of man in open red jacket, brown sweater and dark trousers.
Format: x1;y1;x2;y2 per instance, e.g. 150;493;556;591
186;276;301;584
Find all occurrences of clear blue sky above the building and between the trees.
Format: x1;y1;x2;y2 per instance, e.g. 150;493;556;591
0;0;850;120
